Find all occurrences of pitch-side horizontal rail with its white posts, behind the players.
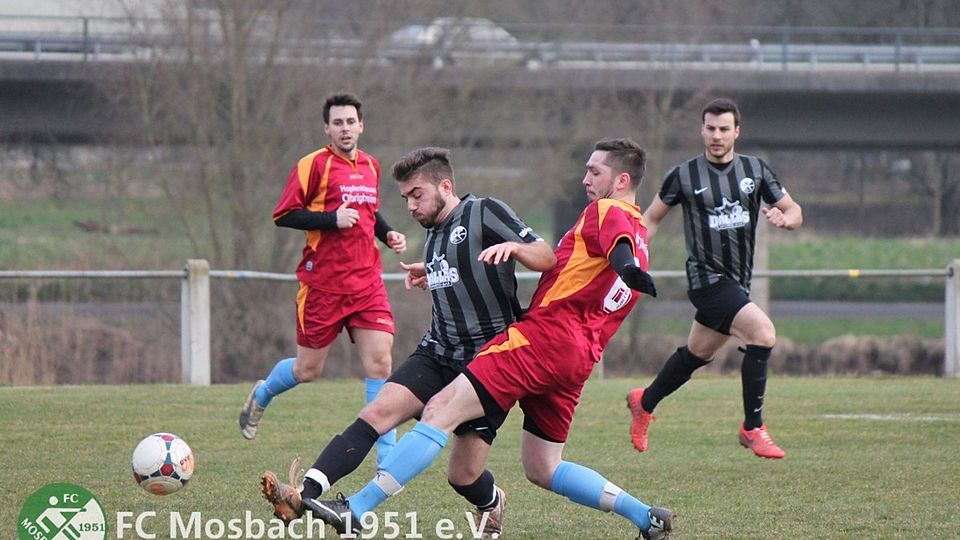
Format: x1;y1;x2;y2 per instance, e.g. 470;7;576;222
0;259;960;385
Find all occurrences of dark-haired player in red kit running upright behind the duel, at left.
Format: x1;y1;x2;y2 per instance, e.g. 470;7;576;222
240;94;407;459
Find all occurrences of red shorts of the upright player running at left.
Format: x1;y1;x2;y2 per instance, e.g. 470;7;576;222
297;281;393;349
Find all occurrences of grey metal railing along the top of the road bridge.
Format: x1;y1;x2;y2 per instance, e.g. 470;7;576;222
0;15;960;71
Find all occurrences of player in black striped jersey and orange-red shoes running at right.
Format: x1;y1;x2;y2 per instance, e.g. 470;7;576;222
627;99;803;459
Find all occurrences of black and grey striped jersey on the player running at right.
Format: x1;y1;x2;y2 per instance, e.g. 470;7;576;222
660;154;787;293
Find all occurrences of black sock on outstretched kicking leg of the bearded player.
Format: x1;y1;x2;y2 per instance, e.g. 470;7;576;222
301;418;380;499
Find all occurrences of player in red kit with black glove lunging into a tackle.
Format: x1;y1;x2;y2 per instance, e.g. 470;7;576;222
304;139;673;539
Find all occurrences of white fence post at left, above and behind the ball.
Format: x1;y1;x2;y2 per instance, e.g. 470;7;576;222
180;259;210;386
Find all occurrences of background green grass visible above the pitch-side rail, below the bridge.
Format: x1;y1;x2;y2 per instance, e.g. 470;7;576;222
0;199;960;270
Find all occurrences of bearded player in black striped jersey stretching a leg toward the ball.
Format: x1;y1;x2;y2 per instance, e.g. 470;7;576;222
261;144;557;536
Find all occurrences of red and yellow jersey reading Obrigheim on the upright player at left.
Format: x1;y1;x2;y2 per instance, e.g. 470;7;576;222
273;145;383;294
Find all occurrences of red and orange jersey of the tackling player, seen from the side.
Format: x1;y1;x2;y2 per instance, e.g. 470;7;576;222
516;199;648;362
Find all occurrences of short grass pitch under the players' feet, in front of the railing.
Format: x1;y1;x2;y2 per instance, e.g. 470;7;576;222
0;377;960;539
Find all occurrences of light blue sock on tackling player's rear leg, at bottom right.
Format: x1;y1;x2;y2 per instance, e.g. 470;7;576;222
550;461;650;531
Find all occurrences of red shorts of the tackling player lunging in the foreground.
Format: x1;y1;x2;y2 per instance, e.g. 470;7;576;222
467;325;595;442
